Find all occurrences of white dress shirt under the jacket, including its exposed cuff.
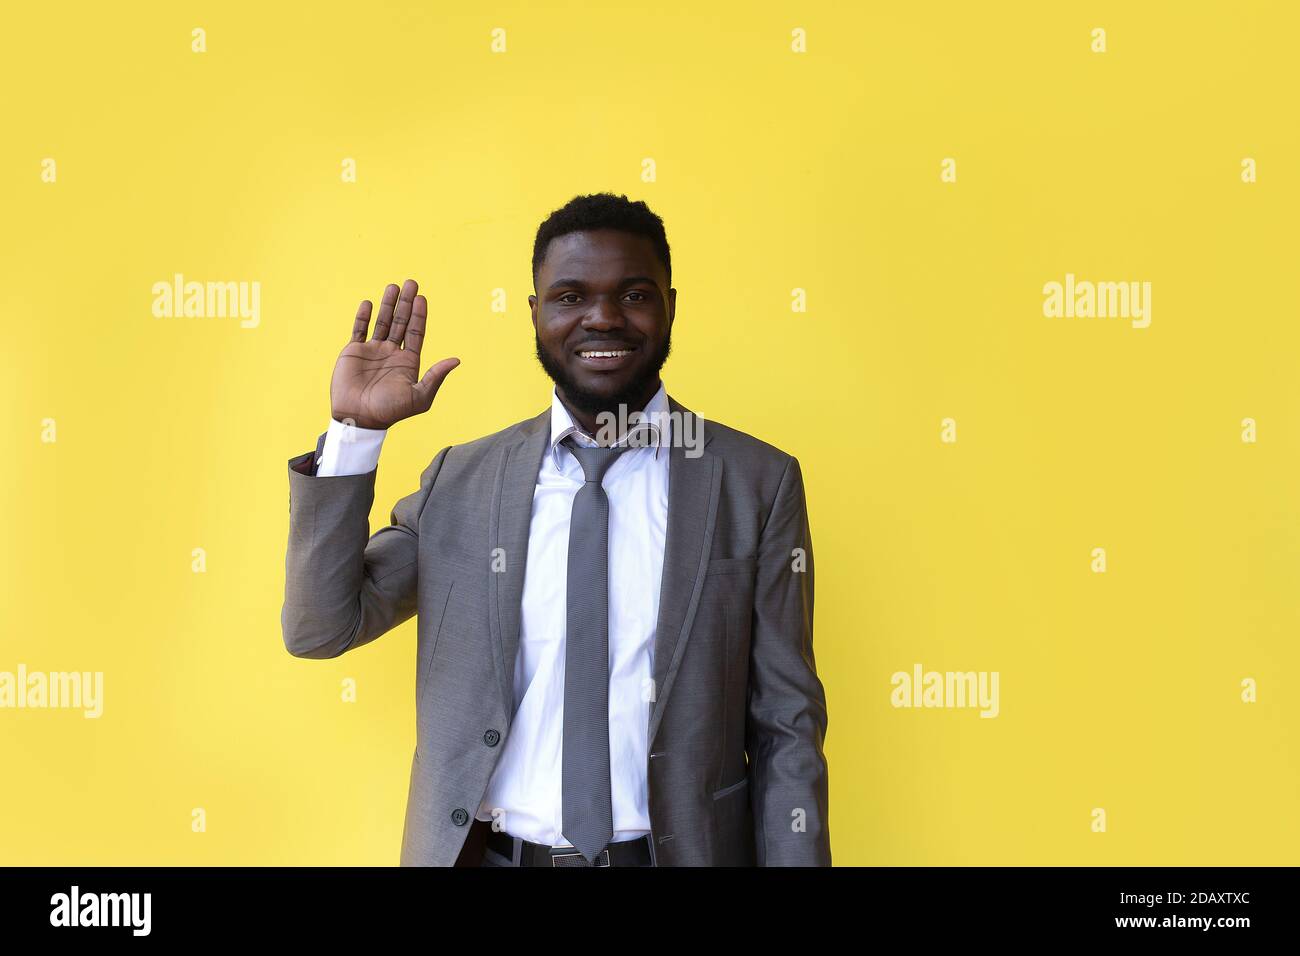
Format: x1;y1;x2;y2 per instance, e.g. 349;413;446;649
316;384;670;847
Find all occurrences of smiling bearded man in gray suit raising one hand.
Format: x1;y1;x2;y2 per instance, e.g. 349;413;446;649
282;194;831;866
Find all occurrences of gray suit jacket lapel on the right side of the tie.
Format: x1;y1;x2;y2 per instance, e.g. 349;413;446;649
649;395;723;745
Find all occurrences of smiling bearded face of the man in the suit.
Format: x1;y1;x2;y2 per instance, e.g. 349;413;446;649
528;229;677;415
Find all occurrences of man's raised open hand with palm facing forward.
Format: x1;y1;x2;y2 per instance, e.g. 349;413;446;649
329;278;460;428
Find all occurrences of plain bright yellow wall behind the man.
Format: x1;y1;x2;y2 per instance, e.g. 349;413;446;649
0;1;1300;865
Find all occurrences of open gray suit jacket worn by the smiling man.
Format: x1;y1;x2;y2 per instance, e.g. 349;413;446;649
281;397;831;866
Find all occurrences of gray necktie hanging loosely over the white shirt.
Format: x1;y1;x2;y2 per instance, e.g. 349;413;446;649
563;436;628;864
